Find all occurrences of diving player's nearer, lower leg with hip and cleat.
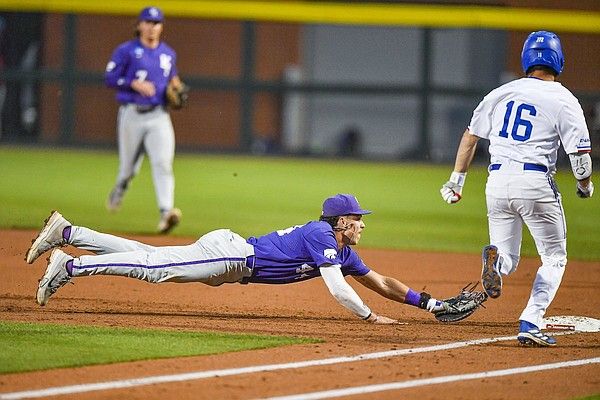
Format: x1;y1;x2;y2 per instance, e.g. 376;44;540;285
37;229;254;305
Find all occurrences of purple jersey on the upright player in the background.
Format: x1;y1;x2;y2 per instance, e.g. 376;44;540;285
104;39;177;106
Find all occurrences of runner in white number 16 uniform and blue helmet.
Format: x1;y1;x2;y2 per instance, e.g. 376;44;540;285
440;31;594;346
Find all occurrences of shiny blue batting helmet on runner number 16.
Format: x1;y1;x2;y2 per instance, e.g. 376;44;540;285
521;31;565;74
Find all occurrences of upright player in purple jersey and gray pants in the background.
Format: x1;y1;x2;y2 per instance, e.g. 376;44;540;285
105;7;181;233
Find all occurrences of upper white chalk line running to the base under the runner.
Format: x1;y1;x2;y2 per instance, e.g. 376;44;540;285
0;331;576;400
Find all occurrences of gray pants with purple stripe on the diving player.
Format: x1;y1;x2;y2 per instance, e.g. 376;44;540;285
69;226;254;286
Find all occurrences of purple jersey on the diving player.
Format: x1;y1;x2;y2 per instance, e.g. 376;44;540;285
243;221;370;284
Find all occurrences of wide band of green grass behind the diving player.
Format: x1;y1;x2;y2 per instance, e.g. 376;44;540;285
0;147;600;260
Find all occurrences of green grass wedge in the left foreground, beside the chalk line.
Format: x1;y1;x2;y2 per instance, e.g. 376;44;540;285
0;321;318;374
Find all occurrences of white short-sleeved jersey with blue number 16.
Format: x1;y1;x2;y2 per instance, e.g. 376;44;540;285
469;78;591;173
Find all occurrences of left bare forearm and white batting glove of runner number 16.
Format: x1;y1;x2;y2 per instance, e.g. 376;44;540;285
440;129;479;204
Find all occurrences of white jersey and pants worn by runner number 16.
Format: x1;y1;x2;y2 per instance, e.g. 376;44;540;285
469;78;591;326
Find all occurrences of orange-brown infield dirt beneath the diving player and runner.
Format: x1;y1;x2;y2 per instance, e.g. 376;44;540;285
0;230;600;400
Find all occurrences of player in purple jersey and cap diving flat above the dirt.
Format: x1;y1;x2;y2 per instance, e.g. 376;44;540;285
26;194;468;324
